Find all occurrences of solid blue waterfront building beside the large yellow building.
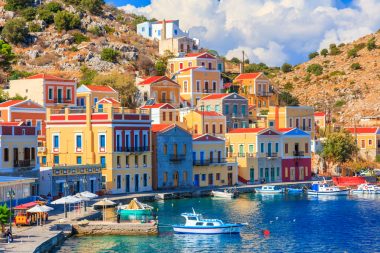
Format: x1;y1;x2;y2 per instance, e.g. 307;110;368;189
152;124;193;190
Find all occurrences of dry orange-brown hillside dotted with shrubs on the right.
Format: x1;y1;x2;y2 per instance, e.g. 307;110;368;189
272;32;380;125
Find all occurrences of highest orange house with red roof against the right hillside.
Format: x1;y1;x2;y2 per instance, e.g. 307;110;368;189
234;72;278;110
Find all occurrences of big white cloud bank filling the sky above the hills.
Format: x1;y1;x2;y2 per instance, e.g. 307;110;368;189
123;0;380;65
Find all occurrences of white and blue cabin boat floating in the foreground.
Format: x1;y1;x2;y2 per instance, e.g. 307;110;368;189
172;209;247;234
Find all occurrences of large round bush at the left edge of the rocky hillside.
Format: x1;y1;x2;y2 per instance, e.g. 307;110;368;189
1;18;28;44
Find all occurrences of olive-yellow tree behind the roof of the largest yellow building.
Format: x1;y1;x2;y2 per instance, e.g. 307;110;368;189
94;72;139;108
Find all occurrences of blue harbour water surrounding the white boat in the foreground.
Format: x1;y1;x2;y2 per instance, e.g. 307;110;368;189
58;194;380;253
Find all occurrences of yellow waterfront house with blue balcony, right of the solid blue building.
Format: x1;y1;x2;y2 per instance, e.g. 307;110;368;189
193;134;238;187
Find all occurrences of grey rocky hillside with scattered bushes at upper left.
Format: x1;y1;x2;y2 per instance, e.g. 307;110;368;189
0;0;158;81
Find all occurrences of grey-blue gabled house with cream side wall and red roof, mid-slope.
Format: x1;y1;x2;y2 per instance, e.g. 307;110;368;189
198;93;249;131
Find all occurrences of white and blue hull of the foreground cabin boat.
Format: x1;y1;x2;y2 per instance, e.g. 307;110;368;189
173;224;243;235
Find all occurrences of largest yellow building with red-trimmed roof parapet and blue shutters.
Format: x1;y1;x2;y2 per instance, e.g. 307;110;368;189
41;96;152;194
